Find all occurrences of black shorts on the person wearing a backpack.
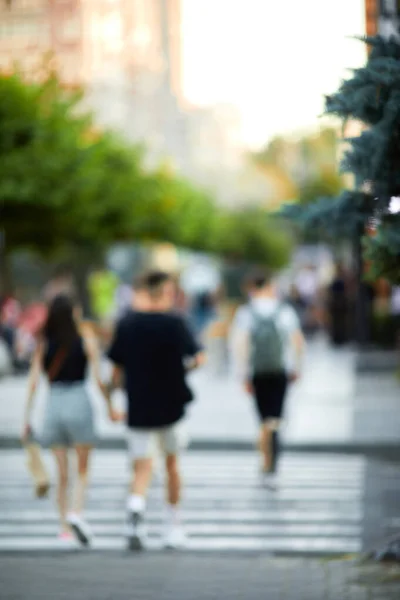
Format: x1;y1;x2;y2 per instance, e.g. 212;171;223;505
253;373;288;421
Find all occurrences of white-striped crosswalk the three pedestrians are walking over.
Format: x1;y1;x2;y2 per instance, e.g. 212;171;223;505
0;450;365;554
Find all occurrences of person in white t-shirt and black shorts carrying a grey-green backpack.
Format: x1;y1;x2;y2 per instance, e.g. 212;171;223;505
231;272;304;484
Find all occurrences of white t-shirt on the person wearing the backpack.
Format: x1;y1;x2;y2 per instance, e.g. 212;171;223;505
230;298;301;377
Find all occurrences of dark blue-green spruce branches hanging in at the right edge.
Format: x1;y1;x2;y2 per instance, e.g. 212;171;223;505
284;36;400;283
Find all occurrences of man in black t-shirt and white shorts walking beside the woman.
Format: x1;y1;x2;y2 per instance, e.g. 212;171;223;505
108;272;204;550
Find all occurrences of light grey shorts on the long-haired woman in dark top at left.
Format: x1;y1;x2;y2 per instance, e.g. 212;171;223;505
41;383;96;448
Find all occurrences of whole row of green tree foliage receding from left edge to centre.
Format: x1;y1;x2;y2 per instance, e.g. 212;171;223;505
0;73;290;267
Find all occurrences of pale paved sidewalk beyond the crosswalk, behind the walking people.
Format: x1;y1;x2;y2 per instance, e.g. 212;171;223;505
0;339;400;451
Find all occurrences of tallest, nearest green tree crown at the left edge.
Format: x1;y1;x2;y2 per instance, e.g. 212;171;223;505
0;75;145;254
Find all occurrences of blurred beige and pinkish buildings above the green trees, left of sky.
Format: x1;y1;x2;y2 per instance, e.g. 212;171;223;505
0;0;247;200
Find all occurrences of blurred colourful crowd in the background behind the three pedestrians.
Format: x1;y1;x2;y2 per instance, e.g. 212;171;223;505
0;246;400;372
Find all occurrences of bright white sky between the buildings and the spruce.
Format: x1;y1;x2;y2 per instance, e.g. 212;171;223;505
182;0;365;147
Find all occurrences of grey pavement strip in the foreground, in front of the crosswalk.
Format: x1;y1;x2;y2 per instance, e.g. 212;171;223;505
0;553;400;600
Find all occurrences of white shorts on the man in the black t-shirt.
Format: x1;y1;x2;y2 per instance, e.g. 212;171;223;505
127;422;188;460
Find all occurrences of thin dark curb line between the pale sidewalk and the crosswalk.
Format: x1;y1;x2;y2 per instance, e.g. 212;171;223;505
0;436;400;462
